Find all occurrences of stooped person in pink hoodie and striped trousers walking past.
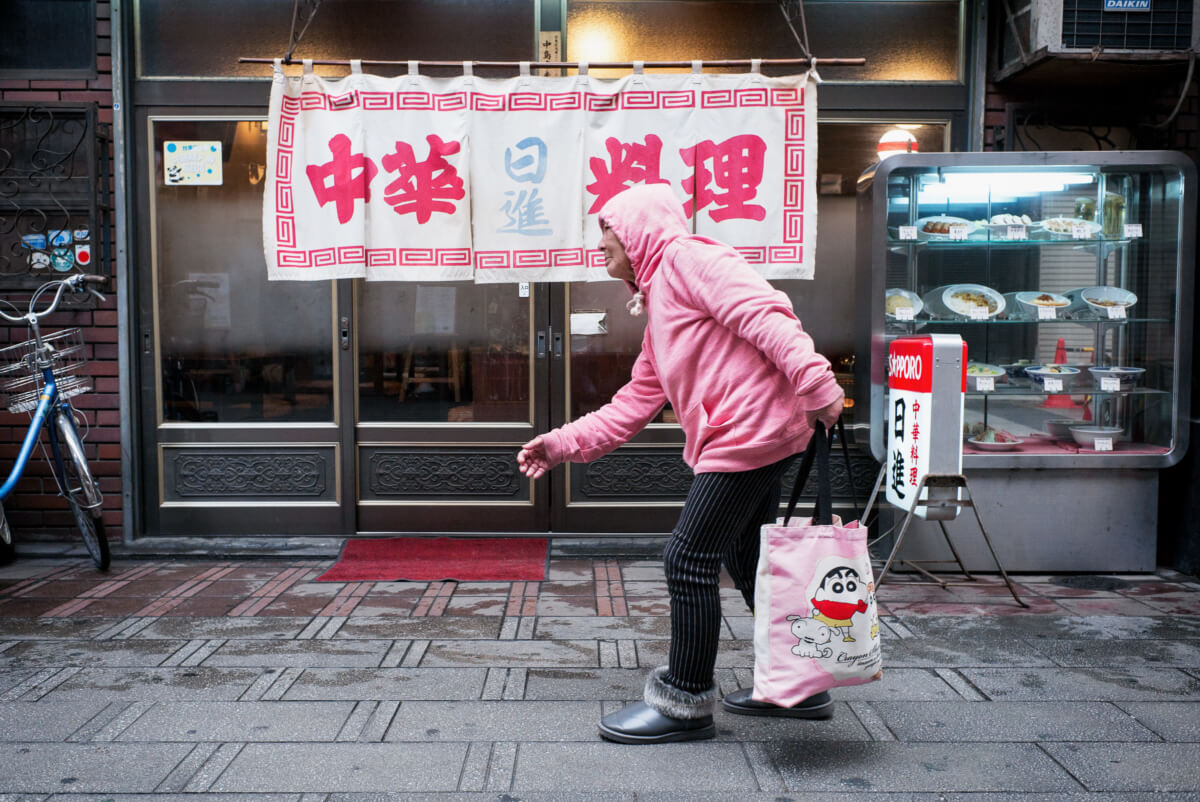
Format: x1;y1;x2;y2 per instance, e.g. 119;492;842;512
517;184;844;743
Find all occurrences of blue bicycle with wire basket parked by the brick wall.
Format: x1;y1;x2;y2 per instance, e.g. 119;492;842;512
0;274;110;571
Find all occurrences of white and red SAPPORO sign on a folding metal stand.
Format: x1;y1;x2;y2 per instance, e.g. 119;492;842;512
864;334;1030;608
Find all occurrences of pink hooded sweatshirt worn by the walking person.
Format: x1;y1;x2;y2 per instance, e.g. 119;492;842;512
542;184;839;473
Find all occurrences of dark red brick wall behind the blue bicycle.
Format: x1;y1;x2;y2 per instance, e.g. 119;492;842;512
0;2;122;541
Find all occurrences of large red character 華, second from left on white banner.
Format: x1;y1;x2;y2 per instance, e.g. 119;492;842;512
380;133;467;223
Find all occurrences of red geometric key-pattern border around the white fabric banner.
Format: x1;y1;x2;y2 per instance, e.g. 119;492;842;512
275;86;804;269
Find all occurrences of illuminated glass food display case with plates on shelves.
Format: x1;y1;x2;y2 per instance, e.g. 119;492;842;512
856;151;1196;571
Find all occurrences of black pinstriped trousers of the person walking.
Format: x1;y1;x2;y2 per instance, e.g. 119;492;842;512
662;457;793;693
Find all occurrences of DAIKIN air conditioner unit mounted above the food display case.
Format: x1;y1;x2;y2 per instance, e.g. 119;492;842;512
992;0;1200;72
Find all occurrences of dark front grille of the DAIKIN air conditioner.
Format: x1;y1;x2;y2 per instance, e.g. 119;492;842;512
1062;0;1193;50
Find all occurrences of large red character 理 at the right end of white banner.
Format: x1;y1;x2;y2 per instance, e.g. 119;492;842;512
679;133;767;222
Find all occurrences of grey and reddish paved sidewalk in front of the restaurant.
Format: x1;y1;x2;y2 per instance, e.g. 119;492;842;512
0;557;1200;802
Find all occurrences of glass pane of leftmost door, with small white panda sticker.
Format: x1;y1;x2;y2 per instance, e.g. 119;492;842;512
150;120;334;423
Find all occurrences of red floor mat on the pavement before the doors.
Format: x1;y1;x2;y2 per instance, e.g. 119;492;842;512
317;538;548;582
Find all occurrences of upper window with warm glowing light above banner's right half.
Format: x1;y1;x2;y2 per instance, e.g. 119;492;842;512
566;0;961;82
